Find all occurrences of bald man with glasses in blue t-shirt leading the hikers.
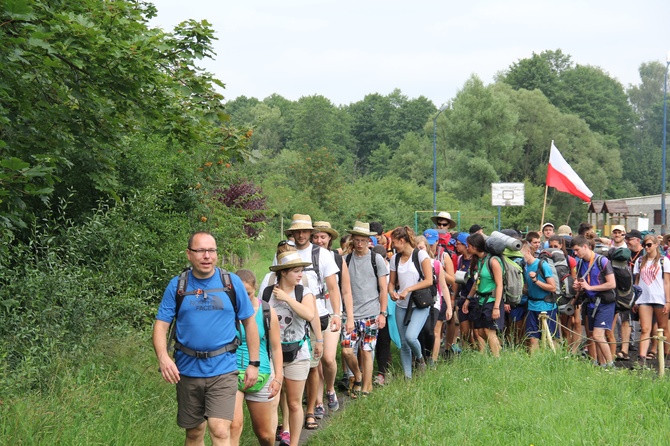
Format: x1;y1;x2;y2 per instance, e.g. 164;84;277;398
153;232;260;444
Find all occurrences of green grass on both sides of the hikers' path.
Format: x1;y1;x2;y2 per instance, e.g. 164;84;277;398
0;334;670;446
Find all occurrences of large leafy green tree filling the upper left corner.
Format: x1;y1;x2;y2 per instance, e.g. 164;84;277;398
0;0;249;235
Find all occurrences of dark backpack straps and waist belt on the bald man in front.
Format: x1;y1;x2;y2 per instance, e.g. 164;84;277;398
167;268;240;358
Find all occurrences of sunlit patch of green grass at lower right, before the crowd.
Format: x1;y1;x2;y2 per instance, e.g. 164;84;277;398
309;351;670;446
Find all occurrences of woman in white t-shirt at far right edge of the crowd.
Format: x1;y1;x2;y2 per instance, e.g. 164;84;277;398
633;234;670;363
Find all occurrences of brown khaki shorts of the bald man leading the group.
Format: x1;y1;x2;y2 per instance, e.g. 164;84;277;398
177;370;237;429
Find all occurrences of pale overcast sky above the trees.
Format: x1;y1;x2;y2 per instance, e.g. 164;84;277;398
151;0;670;107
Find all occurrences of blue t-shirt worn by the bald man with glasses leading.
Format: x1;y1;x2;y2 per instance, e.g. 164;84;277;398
156;268;254;378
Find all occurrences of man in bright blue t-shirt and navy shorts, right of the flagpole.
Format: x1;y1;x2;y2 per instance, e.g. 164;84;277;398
521;241;561;352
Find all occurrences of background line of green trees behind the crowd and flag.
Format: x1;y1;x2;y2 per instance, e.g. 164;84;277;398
232;50;665;233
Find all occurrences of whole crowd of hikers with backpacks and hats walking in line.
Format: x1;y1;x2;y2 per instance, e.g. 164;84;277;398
154;212;670;445
